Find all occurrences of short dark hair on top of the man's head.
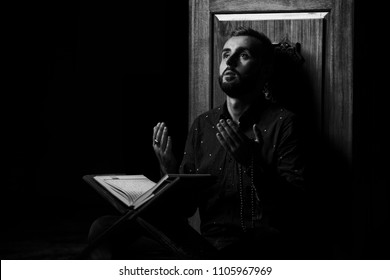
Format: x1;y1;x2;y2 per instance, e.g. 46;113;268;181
230;26;274;69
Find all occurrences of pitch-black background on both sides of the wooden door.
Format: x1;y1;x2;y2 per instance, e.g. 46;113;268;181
1;0;390;259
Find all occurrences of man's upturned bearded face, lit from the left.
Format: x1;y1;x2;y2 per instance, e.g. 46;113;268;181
219;36;261;98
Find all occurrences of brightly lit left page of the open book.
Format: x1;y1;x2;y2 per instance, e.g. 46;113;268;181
95;175;156;206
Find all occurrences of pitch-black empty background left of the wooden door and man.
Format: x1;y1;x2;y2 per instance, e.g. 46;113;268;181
1;0;188;257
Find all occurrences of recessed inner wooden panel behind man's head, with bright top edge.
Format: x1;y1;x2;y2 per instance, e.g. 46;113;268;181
211;12;327;131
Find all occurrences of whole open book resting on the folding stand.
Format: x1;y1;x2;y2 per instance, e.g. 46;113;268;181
83;174;211;210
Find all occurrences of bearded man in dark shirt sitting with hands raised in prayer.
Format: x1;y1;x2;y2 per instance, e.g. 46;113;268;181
153;28;303;259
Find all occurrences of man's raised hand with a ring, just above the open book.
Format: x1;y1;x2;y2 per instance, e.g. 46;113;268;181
153;122;177;174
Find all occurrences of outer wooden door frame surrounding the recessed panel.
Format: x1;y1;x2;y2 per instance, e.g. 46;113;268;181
189;0;354;166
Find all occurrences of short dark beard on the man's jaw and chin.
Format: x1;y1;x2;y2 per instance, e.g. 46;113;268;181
218;69;259;98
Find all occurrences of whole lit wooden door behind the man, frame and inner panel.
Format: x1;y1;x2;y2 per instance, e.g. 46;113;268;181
189;0;354;164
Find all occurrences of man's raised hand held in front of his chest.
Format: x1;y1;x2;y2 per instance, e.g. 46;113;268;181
217;120;263;165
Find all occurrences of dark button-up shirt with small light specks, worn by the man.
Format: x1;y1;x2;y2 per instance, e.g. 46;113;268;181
180;98;303;249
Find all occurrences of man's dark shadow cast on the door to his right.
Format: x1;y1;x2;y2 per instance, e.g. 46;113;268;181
270;40;353;259
